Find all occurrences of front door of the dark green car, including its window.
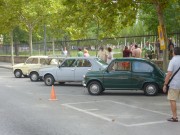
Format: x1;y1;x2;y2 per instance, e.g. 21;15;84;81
103;61;131;89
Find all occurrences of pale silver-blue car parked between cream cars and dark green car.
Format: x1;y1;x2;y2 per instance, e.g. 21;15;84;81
39;57;107;86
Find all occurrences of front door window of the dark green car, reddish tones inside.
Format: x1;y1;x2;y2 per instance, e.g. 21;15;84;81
109;61;131;71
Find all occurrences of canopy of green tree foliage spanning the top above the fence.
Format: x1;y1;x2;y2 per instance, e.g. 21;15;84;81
0;0;180;51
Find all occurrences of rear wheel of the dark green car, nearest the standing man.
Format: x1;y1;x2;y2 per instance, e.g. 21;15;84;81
144;83;158;96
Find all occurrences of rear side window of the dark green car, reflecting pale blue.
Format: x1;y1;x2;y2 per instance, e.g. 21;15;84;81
132;61;153;72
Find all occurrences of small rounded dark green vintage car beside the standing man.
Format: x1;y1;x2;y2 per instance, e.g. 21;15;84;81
82;58;165;96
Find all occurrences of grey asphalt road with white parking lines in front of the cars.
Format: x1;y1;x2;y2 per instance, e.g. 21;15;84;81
0;68;180;135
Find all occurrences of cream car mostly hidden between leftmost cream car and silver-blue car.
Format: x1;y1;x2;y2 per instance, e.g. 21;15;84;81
27;57;65;82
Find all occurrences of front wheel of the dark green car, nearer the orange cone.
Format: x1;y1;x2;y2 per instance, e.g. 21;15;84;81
88;81;103;95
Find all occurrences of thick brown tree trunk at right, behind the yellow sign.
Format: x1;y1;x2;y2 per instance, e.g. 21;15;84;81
155;3;168;71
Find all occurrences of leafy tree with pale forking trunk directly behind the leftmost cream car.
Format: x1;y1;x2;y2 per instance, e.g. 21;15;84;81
18;0;59;55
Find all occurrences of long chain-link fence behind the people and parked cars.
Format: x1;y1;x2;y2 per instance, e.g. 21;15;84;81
0;33;180;56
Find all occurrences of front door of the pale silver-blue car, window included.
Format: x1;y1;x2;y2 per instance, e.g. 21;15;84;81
56;58;76;81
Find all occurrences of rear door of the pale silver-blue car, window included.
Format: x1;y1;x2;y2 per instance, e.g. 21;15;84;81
75;59;92;81
